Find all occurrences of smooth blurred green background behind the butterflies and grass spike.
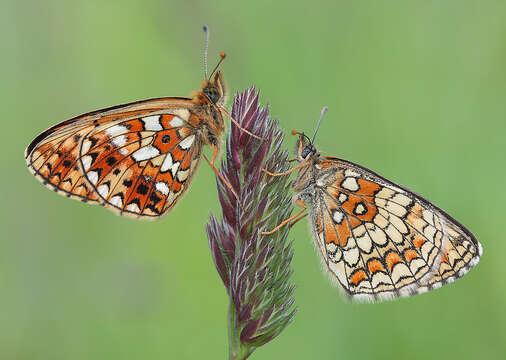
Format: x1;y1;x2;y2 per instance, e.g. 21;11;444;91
0;0;506;360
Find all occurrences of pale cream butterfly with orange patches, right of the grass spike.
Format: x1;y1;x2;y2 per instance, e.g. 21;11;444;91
263;107;482;301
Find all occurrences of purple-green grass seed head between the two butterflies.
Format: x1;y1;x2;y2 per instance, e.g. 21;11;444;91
206;88;295;359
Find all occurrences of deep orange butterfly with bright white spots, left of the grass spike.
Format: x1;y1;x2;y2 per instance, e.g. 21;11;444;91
25;26;256;219
